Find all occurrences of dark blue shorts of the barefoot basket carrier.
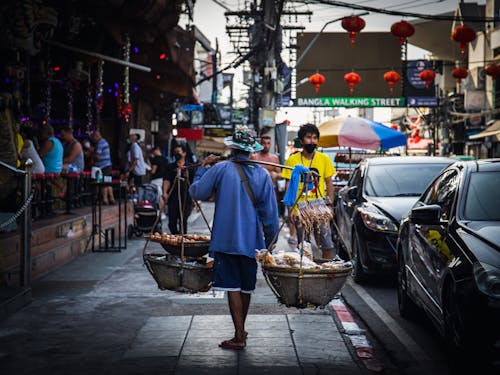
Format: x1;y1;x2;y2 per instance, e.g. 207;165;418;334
212;252;257;293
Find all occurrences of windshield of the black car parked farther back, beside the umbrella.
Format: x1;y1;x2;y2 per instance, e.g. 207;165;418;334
365;163;447;197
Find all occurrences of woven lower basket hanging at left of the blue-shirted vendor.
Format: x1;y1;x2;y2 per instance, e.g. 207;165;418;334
143;254;212;293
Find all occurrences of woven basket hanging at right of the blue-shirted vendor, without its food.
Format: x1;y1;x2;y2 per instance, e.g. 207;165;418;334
262;264;351;308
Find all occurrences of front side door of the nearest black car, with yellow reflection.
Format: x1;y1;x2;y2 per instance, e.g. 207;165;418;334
410;170;459;318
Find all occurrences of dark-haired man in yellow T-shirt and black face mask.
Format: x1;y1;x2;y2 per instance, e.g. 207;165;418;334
281;124;335;259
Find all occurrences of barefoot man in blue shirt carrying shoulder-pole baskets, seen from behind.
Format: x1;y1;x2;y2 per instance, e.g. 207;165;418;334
189;128;279;350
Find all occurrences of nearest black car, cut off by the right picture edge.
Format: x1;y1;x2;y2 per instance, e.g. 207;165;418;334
397;159;500;359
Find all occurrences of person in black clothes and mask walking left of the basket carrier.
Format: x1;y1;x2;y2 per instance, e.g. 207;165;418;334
163;143;196;234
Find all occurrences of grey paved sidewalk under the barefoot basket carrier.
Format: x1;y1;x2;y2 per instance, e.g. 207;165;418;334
0;206;368;375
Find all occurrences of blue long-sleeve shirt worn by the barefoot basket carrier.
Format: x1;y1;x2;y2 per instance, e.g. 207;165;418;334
189;155;279;258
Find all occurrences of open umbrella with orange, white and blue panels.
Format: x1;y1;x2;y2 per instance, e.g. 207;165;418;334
318;117;406;150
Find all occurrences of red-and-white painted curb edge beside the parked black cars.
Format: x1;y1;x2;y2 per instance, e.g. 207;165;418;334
328;298;384;372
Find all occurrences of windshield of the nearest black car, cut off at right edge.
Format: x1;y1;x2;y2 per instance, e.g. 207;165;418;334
464;172;500;221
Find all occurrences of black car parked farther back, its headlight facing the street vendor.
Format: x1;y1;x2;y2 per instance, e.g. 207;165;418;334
335;156;454;282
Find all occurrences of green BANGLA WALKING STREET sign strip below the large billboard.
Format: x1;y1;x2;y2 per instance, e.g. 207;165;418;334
297;97;406;107
